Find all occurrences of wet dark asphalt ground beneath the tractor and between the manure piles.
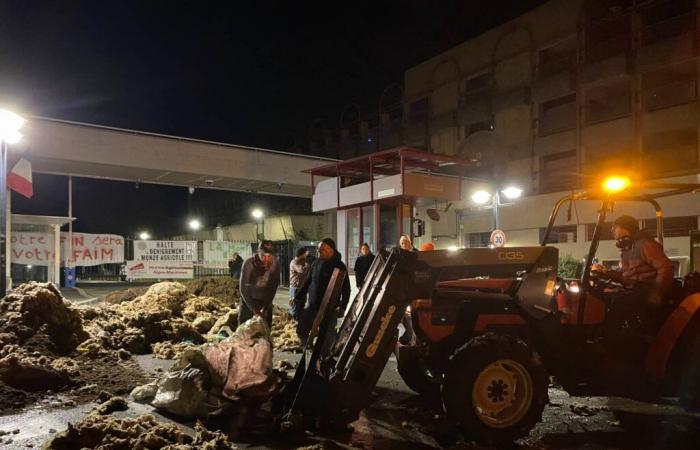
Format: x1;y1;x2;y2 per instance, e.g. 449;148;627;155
0;286;700;450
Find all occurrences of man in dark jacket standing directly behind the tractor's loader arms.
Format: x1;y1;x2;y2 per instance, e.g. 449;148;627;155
294;238;350;344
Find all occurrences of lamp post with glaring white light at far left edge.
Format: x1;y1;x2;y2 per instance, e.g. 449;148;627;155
0;109;26;297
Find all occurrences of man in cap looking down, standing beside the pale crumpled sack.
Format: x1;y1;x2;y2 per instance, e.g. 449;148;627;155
238;240;280;326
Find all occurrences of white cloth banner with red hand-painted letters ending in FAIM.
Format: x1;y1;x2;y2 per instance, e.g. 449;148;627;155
11;231;124;266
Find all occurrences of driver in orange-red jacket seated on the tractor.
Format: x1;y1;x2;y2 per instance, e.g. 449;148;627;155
593;216;673;307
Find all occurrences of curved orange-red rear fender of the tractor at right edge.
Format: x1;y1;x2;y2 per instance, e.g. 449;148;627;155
644;293;700;381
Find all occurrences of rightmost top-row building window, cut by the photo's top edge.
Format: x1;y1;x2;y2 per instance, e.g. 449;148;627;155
640;0;696;45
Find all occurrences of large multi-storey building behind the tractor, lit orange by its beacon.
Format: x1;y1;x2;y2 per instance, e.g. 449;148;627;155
314;0;700;271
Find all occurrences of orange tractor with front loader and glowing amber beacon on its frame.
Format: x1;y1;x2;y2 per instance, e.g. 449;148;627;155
288;178;700;443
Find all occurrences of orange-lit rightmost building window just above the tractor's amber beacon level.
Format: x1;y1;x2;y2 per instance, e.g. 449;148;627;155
642;128;698;176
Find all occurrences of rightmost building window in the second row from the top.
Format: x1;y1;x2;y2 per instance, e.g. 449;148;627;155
642;61;697;111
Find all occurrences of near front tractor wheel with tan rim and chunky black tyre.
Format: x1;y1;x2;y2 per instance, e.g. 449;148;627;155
442;333;549;444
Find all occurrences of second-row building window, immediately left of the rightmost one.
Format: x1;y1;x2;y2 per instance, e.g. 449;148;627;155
586;79;632;123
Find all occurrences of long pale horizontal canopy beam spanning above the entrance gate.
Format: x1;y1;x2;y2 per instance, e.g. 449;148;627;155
24;117;335;197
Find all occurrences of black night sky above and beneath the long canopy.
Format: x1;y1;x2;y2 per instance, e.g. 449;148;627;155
0;0;543;234
